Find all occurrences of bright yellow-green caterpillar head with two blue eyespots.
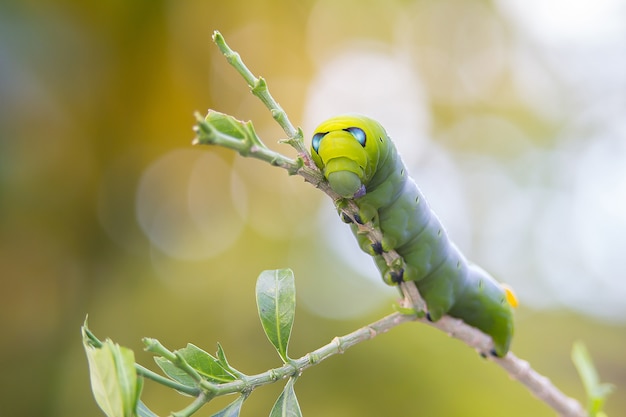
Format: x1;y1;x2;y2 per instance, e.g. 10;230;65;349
311;114;389;198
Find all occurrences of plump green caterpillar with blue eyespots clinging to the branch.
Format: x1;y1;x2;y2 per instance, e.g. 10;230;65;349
311;114;517;357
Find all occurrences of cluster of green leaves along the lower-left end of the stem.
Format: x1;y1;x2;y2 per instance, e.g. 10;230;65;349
81;269;302;417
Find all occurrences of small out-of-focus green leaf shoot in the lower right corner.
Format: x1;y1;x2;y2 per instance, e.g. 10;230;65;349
572;342;613;417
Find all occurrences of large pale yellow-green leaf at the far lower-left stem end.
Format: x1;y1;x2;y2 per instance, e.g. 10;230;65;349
82;324;142;417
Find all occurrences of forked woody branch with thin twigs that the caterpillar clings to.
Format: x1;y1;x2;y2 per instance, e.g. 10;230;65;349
194;32;587;417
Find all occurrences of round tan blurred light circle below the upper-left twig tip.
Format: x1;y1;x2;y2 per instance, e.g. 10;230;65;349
136;150;247;260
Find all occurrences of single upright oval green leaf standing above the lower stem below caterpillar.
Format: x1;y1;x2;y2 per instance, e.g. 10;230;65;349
256;269;296;363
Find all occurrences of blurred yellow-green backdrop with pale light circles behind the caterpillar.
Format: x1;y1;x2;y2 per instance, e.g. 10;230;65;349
0;0;626;417
